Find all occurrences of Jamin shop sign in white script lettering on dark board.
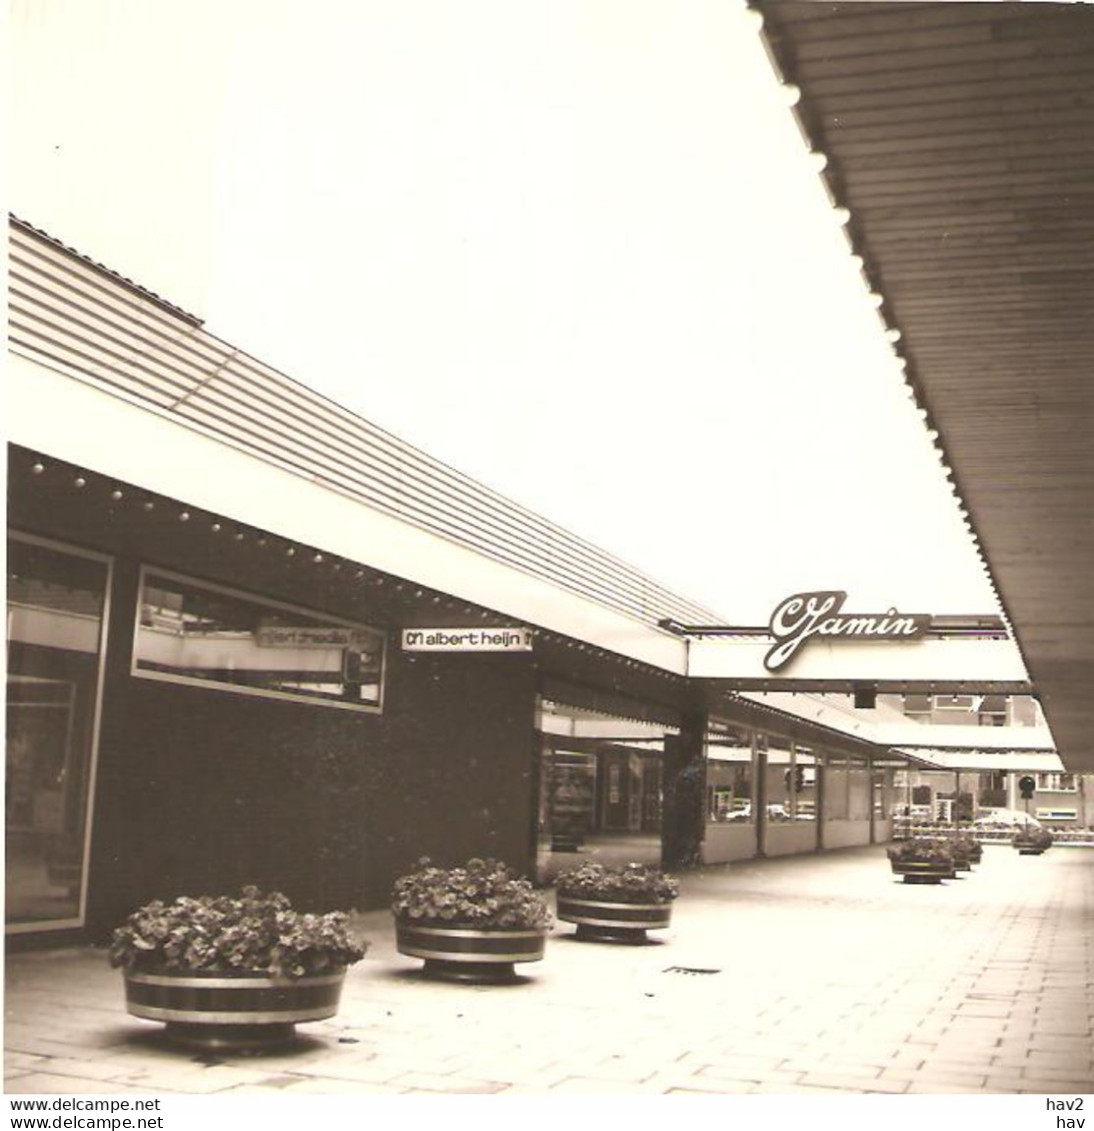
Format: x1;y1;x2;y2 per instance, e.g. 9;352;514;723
764;589;931;672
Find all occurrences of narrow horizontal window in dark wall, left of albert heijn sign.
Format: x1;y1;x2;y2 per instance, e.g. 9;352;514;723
132;567;384;710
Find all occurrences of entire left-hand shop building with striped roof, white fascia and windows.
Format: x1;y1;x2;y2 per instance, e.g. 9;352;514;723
6;213;905;941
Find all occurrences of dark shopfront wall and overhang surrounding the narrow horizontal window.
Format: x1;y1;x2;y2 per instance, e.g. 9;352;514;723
9;449;537;938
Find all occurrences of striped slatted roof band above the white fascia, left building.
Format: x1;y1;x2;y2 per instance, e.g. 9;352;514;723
9;217;716;624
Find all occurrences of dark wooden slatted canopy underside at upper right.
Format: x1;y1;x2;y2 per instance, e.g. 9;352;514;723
756;0;1094;770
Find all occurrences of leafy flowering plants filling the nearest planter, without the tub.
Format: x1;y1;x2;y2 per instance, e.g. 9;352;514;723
109;887;368;977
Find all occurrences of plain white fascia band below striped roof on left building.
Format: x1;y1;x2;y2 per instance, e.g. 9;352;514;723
7;354;687;675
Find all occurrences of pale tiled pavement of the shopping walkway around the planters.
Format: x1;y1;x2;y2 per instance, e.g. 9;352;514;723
5;846;1094;1096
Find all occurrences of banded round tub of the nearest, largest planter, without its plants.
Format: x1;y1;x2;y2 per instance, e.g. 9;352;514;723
124;969;345;1051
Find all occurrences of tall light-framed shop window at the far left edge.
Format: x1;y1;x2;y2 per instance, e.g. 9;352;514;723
5;536;110;929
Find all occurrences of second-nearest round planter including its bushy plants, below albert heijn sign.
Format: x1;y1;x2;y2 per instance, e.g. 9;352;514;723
391;857;551;982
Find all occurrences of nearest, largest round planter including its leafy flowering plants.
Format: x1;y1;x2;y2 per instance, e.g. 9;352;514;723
109;887;368;1050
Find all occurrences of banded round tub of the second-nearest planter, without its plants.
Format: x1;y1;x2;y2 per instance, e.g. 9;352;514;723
395;918;546;984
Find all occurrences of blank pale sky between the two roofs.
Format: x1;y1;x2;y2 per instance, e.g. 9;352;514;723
10;0;997;623
